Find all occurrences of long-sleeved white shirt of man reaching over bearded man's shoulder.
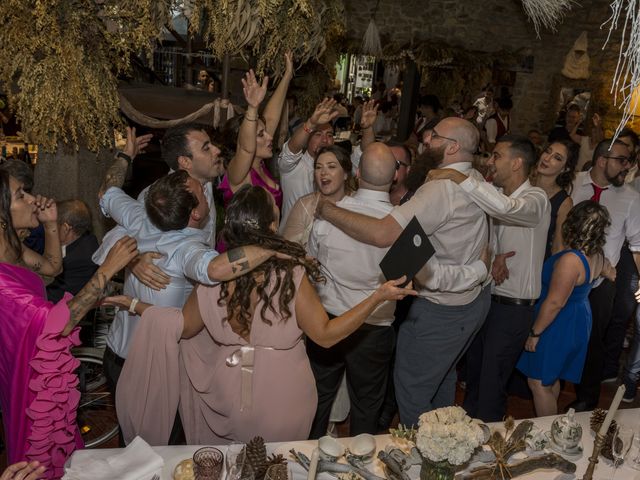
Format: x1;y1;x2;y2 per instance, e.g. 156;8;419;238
460;178;551;300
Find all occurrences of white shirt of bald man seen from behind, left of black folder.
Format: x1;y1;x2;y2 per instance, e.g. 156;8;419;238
308;188;396;326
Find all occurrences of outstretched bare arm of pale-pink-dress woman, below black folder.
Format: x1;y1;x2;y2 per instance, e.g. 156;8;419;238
296;275;417;348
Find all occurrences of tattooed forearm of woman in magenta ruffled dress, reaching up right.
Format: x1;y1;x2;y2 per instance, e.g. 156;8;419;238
62;237;138;335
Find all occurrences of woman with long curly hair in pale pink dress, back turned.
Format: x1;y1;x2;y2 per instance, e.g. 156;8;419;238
113;185;415;445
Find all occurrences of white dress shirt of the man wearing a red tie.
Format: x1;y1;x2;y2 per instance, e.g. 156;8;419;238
571;171;640;267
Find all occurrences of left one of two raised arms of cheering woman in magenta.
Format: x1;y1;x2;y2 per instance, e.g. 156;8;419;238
227;70;269;187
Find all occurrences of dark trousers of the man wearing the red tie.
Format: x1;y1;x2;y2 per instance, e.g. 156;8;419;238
576;279;616;410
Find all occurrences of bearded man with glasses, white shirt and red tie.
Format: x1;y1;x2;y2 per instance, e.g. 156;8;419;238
570;139;640;411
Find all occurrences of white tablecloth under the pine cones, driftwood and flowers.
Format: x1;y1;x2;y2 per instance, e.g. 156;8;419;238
65;408;640;480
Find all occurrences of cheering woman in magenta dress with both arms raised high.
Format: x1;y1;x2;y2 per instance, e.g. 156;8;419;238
218;53;293;208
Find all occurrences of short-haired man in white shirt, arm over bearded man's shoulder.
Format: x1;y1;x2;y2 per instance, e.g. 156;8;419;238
429;135;551;422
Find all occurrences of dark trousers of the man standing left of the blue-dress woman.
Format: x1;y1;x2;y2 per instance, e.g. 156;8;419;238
464;300;535;422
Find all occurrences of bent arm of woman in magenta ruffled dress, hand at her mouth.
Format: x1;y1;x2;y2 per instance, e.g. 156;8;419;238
22;195;62;277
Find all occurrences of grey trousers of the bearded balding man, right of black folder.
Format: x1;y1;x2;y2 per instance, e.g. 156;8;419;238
394;287;491;426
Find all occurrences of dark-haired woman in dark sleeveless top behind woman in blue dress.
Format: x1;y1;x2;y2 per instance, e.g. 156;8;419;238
531;140;580;260
